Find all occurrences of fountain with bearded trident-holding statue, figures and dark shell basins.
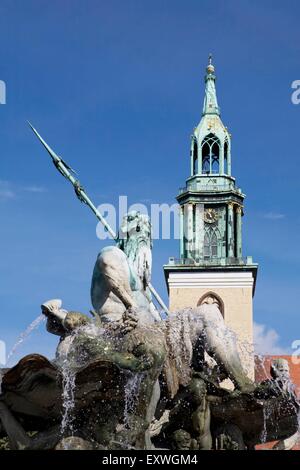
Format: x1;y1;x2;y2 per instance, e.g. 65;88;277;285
0;126;299;450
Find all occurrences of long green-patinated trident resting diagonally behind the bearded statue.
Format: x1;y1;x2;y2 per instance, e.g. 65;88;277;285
28;121;170;315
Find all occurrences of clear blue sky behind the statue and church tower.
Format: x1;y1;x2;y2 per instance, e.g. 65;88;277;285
0;0;300;359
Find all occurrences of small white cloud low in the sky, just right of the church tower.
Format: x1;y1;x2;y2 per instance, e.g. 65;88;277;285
254;323;291;356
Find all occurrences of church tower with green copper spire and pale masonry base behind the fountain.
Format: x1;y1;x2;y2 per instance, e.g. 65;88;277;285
164;56;258;376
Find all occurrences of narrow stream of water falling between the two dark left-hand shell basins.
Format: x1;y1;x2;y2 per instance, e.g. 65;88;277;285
61;361;75;436
